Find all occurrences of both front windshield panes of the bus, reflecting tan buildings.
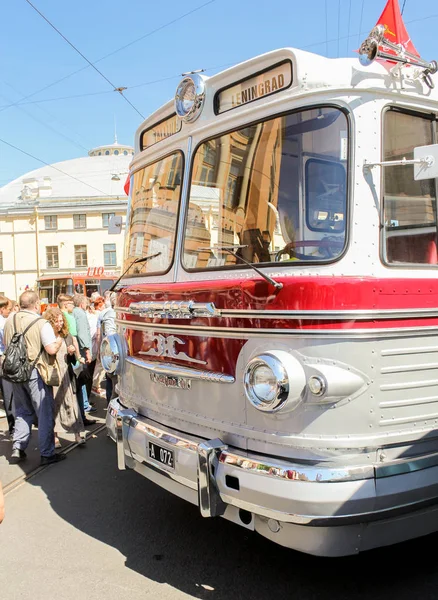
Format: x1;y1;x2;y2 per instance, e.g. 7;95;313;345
124;108;347;275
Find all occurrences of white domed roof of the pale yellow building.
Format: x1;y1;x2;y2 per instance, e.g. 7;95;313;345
0;143;134;207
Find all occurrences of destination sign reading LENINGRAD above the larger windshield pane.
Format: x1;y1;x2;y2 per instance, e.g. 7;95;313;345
216;61;292;114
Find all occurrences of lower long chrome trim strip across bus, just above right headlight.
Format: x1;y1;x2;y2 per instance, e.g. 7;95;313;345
116;319;438;339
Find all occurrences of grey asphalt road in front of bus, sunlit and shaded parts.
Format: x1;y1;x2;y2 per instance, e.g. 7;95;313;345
0;433;438;600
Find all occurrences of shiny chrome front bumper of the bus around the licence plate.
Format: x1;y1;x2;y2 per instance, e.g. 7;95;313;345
107;399;438;528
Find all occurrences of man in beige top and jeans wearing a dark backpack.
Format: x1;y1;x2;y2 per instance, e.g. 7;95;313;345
3;291;66;465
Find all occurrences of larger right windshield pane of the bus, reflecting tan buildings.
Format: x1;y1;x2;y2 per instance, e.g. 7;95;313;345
184;108;348;269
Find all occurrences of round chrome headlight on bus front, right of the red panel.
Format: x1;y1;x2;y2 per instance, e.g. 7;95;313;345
244;350;306;412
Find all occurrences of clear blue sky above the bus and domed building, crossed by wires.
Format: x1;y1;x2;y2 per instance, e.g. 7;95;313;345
0;0;438;186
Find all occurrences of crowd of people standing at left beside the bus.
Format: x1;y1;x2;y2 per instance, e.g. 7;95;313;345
0;291;116;465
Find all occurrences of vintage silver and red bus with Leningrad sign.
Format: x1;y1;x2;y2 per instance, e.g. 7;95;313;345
101;18;438;556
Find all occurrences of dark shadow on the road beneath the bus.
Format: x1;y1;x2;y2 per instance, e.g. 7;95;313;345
24;433;438;600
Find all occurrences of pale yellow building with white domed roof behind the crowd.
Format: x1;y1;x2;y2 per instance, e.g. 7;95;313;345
0;142;133;298
